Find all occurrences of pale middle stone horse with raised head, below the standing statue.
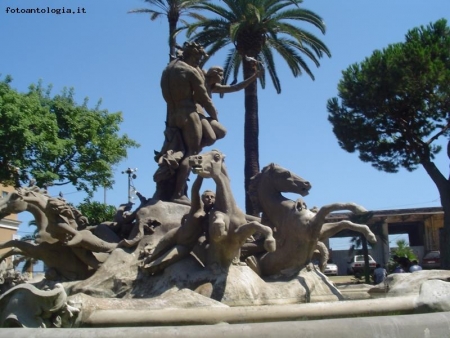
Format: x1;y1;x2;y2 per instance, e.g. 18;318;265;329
189;150;275;270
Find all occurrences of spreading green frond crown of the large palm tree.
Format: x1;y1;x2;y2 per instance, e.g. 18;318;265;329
187;0;331;93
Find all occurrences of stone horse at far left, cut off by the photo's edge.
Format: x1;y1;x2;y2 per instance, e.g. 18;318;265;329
0;187;123;279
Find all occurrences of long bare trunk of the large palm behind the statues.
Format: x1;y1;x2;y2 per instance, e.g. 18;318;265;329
243;60;259;216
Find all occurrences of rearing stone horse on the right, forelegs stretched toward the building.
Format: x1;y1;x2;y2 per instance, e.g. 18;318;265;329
249;163;376;276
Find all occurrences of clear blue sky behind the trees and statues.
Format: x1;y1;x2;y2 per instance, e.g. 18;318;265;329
0;0;450;243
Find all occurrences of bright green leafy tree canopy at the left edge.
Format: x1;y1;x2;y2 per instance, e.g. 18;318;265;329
0;76;139;194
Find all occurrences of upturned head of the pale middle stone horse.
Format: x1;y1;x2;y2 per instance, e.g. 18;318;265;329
189;150;228;178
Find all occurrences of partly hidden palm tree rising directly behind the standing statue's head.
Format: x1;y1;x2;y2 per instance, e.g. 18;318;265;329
128;0;206;58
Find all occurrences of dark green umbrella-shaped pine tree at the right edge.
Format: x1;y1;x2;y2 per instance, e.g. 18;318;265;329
327;19;450;268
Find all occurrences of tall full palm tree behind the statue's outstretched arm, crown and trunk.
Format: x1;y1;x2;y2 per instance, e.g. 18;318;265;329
187;0;331;214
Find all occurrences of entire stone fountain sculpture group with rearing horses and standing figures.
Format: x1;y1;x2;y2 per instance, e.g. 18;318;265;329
0;43;446;327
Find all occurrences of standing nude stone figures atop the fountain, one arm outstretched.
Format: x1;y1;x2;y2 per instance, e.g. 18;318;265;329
154;42;259;204
